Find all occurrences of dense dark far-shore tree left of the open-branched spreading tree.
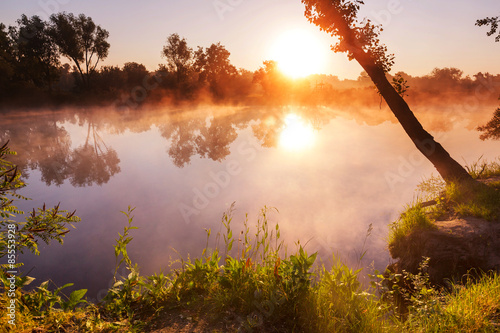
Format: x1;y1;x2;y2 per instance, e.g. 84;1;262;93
10;14;59;91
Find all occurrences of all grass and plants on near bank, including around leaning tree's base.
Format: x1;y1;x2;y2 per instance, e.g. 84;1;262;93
0;147;500;332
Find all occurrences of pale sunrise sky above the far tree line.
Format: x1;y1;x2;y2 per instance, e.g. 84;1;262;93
0;0;500;79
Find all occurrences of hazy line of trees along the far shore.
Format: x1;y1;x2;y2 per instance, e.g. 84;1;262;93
0;13;500;108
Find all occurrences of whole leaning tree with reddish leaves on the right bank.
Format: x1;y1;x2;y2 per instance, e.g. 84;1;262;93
302;0;472;182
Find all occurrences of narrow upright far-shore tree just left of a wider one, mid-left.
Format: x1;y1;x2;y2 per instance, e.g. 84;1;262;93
162;34;193;85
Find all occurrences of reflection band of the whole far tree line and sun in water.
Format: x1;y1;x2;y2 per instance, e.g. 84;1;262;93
0;102;488;187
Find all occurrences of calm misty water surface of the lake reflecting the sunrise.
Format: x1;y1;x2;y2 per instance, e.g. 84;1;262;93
0;105;499;299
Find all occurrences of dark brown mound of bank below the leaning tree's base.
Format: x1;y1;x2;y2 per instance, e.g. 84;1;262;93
389;217;500;285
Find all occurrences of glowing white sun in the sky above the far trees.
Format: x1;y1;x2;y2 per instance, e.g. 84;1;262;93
271;29;329;79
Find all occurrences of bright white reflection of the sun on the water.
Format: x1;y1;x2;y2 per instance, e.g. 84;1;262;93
279;113;315;151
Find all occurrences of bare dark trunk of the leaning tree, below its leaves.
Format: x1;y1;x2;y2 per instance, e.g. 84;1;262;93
353;49;472;183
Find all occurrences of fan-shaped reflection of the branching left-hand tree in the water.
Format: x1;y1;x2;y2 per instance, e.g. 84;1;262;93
67;122;120;186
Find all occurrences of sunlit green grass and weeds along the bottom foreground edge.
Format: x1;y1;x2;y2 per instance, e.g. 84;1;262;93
0;202;500;332
